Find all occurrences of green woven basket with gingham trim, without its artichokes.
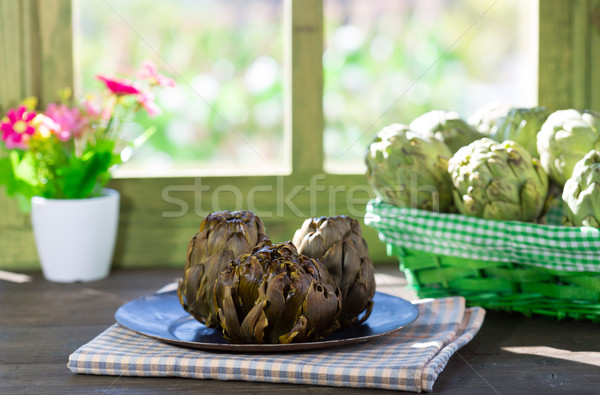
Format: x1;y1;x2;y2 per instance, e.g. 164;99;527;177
365;200;600;321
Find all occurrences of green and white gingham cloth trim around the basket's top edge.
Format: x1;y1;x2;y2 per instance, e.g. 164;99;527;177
365;199;600;272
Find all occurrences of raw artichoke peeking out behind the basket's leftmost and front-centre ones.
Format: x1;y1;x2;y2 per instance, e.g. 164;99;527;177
410;110;483;153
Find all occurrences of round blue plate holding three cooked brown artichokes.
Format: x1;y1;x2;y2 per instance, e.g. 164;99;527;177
115;291;418;352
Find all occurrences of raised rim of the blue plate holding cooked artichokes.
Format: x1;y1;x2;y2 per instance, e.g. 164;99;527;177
115;290;419;353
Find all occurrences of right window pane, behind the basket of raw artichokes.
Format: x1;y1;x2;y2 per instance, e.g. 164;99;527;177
323;0;537;172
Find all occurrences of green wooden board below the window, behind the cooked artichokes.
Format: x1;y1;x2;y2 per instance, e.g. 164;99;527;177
0;174;395;268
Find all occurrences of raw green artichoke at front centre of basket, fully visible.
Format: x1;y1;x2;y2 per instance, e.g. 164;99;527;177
448;138;548;222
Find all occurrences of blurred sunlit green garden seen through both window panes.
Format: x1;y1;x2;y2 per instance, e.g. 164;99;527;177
74;0;535;173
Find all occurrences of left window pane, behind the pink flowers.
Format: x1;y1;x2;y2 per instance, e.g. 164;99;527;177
73;0;289;176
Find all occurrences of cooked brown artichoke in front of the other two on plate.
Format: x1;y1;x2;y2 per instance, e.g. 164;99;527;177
214;242;342;344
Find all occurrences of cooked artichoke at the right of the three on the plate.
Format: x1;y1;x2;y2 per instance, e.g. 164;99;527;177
294;216;375;326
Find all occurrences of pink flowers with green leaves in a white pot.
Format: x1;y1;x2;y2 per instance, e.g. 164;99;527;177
0;61;174;282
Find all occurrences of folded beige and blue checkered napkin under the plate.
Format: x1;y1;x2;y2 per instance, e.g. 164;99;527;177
68;297;485;392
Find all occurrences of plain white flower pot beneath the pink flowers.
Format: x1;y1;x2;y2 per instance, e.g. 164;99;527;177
31;189;119;283
